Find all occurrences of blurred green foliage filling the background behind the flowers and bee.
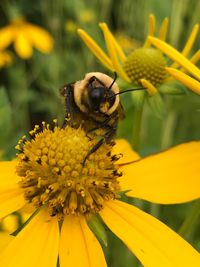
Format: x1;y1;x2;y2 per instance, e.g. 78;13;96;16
0;0;200;267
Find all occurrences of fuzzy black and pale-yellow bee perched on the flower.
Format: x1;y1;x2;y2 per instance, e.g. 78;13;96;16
60;72;143;160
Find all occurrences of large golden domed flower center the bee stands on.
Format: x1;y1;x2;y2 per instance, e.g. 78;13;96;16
16;123;121;219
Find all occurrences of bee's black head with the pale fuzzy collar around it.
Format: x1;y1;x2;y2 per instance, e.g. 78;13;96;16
74;72;119;115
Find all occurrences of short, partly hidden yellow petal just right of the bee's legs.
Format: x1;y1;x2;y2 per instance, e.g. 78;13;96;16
112;139;140;165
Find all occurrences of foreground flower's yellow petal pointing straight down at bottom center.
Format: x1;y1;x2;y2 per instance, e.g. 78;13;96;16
59;215;107;267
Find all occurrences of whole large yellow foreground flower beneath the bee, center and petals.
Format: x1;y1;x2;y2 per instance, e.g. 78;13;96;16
0;123;200;267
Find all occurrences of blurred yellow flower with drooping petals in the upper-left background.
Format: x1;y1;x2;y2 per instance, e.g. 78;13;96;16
0;18;53;59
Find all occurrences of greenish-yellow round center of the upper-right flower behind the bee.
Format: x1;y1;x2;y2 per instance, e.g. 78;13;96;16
124;48;167;86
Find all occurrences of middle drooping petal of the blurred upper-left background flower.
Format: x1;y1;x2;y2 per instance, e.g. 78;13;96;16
14;30;33;59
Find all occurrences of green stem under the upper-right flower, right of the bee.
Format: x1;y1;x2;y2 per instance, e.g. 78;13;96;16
132;105;144;152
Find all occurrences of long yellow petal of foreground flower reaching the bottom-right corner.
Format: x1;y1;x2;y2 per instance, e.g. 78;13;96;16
100;201;200;267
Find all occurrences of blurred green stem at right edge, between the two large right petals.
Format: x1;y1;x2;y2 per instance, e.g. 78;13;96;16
178;200;200;239
